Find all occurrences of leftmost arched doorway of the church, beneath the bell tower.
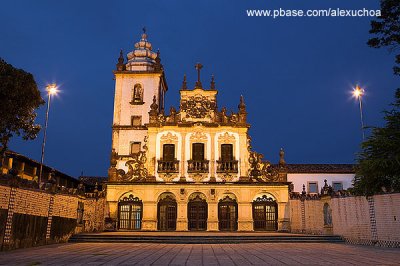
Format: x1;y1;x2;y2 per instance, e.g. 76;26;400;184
118;194;143;230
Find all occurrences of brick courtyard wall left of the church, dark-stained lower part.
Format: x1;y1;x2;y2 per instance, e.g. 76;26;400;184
0;185;105;250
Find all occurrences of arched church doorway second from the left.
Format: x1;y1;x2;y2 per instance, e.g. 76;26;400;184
157;193;177;231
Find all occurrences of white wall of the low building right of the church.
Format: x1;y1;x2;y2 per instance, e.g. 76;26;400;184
287;173;354;192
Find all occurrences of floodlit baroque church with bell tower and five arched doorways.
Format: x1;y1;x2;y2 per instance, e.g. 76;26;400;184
106;32;350;231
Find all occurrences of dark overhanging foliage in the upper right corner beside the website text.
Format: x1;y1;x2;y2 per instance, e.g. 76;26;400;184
368;0;400;75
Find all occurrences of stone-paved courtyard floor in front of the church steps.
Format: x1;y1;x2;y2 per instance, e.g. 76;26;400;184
0;243;400;266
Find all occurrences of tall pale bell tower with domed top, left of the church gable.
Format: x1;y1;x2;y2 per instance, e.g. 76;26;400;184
110;28;168;179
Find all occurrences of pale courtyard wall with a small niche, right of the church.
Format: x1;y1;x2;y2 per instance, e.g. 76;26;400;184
289;193;400;247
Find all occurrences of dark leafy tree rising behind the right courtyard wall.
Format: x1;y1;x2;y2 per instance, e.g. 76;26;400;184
354;88;400;196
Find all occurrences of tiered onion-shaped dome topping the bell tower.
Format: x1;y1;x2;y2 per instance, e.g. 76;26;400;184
126;29;158;71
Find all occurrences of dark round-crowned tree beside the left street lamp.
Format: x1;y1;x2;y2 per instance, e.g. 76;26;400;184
0;58;44;158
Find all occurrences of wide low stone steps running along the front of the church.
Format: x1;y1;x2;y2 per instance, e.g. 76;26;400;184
68;232;344;244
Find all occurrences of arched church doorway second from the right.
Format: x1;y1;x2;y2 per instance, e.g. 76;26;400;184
218;195;238;231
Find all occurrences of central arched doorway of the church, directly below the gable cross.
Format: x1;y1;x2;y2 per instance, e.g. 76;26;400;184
188;193;208;231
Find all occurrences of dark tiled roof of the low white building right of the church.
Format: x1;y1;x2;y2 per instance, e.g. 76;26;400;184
286;164;355;174
